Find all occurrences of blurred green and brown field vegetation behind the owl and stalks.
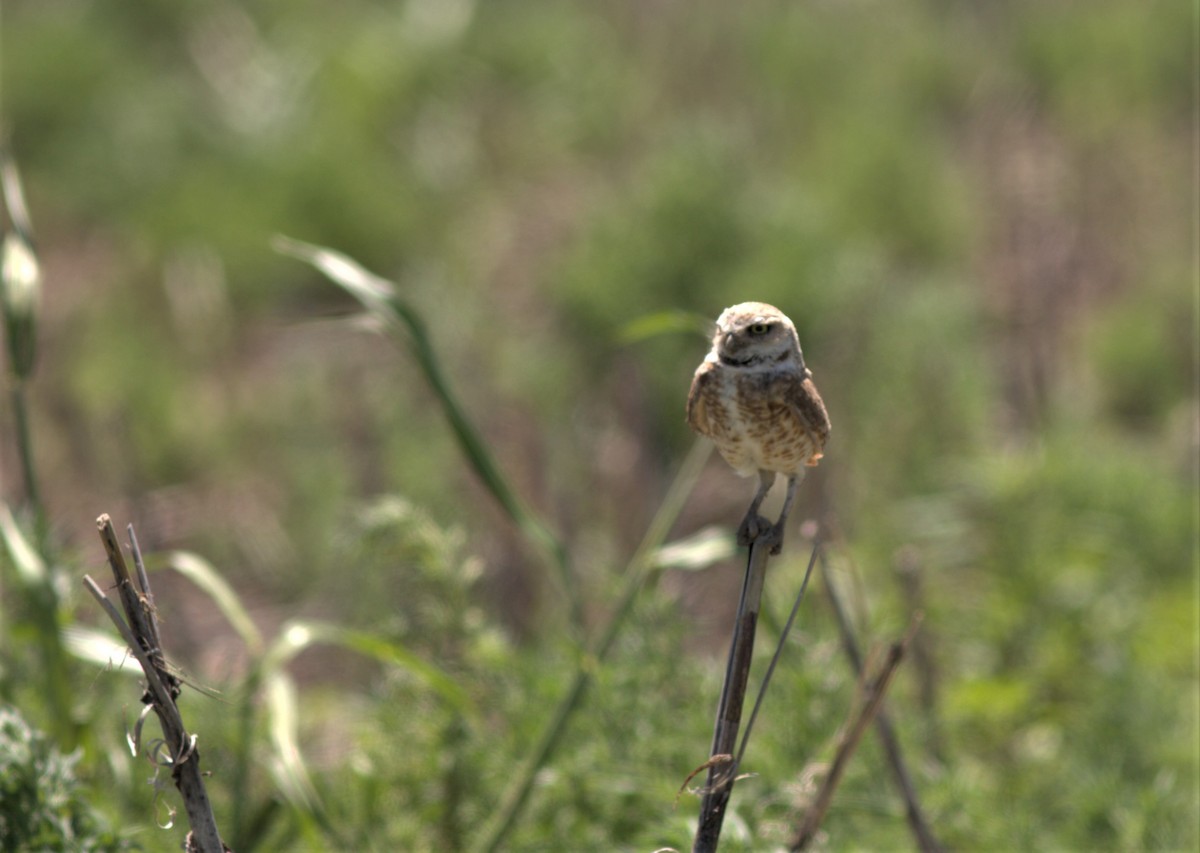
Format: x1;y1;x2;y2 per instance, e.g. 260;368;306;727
0;0;1200;851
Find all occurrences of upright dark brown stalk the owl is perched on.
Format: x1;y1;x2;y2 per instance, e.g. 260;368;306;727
691;540;770;853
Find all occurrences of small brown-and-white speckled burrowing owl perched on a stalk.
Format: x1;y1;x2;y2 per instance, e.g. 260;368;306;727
688;302;829;554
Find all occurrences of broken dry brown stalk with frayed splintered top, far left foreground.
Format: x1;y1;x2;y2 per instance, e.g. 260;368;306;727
84;513;232;853
